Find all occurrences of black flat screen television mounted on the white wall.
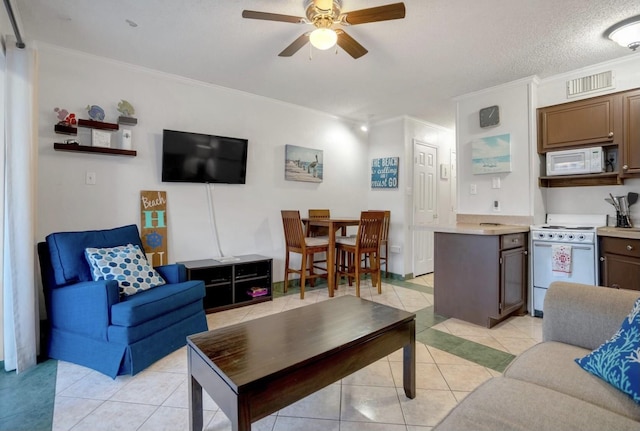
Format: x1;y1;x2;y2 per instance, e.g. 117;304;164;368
162;129;248;184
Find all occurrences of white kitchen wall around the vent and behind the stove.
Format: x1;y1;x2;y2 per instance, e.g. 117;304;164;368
537;53;640;225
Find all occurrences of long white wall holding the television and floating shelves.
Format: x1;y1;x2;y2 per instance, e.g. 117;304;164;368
36;43;370;281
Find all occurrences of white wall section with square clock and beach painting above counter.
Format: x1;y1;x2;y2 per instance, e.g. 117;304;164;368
456;78;537;216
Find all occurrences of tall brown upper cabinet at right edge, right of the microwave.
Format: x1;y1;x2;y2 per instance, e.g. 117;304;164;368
622;89;640;176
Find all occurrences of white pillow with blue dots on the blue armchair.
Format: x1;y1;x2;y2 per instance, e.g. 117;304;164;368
85;244;166;295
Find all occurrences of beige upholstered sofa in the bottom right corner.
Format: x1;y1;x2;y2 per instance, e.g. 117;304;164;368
434;282;640;431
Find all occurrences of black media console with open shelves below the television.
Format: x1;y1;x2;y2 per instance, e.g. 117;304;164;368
179;254;273;313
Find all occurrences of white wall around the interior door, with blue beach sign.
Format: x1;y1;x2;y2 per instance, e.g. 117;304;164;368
368;117;455;276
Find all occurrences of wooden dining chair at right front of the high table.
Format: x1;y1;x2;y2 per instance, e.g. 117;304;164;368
336;211;384;296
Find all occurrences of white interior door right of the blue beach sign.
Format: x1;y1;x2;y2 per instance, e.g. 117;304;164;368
412;140;438;276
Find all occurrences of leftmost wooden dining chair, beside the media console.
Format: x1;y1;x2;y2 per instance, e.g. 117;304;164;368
281;210;329;299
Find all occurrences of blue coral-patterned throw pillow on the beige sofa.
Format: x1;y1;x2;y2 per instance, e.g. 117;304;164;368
576;298;640;404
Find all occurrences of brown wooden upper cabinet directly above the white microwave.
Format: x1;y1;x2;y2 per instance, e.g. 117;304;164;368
538;94;622;153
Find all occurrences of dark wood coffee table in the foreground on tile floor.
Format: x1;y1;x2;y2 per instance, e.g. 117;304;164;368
187;296;416;431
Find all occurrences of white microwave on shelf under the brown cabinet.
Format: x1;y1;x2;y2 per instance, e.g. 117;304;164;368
547;147;605;176
